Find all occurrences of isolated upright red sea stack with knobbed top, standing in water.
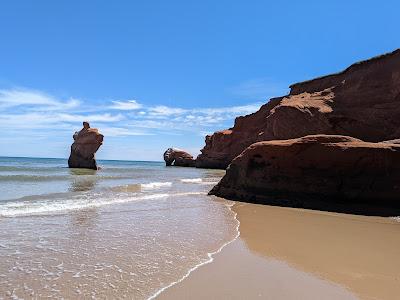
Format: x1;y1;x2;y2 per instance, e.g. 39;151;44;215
68;122;104;170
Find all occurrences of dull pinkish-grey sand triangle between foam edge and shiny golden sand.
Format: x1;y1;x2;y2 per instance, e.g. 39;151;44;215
157;238;357;300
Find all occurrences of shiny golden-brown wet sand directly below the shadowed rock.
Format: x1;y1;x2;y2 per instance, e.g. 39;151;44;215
234;203;400;299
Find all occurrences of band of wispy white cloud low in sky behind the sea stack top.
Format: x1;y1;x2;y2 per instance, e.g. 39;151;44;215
0;89;261;137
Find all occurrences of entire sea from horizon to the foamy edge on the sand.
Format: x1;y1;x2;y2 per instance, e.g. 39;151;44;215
0;157;238;299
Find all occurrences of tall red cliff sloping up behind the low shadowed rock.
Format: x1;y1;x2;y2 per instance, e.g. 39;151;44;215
196;49;400;168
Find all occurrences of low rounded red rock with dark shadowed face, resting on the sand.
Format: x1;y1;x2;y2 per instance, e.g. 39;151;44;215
210;135;400;215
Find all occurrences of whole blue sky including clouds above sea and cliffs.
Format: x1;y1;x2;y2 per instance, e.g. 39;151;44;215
0;0;400;160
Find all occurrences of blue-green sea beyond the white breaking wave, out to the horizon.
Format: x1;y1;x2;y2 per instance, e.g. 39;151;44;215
0;157;177;201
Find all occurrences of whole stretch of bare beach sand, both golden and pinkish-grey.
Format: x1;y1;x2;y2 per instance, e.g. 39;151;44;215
160;203;400;299
